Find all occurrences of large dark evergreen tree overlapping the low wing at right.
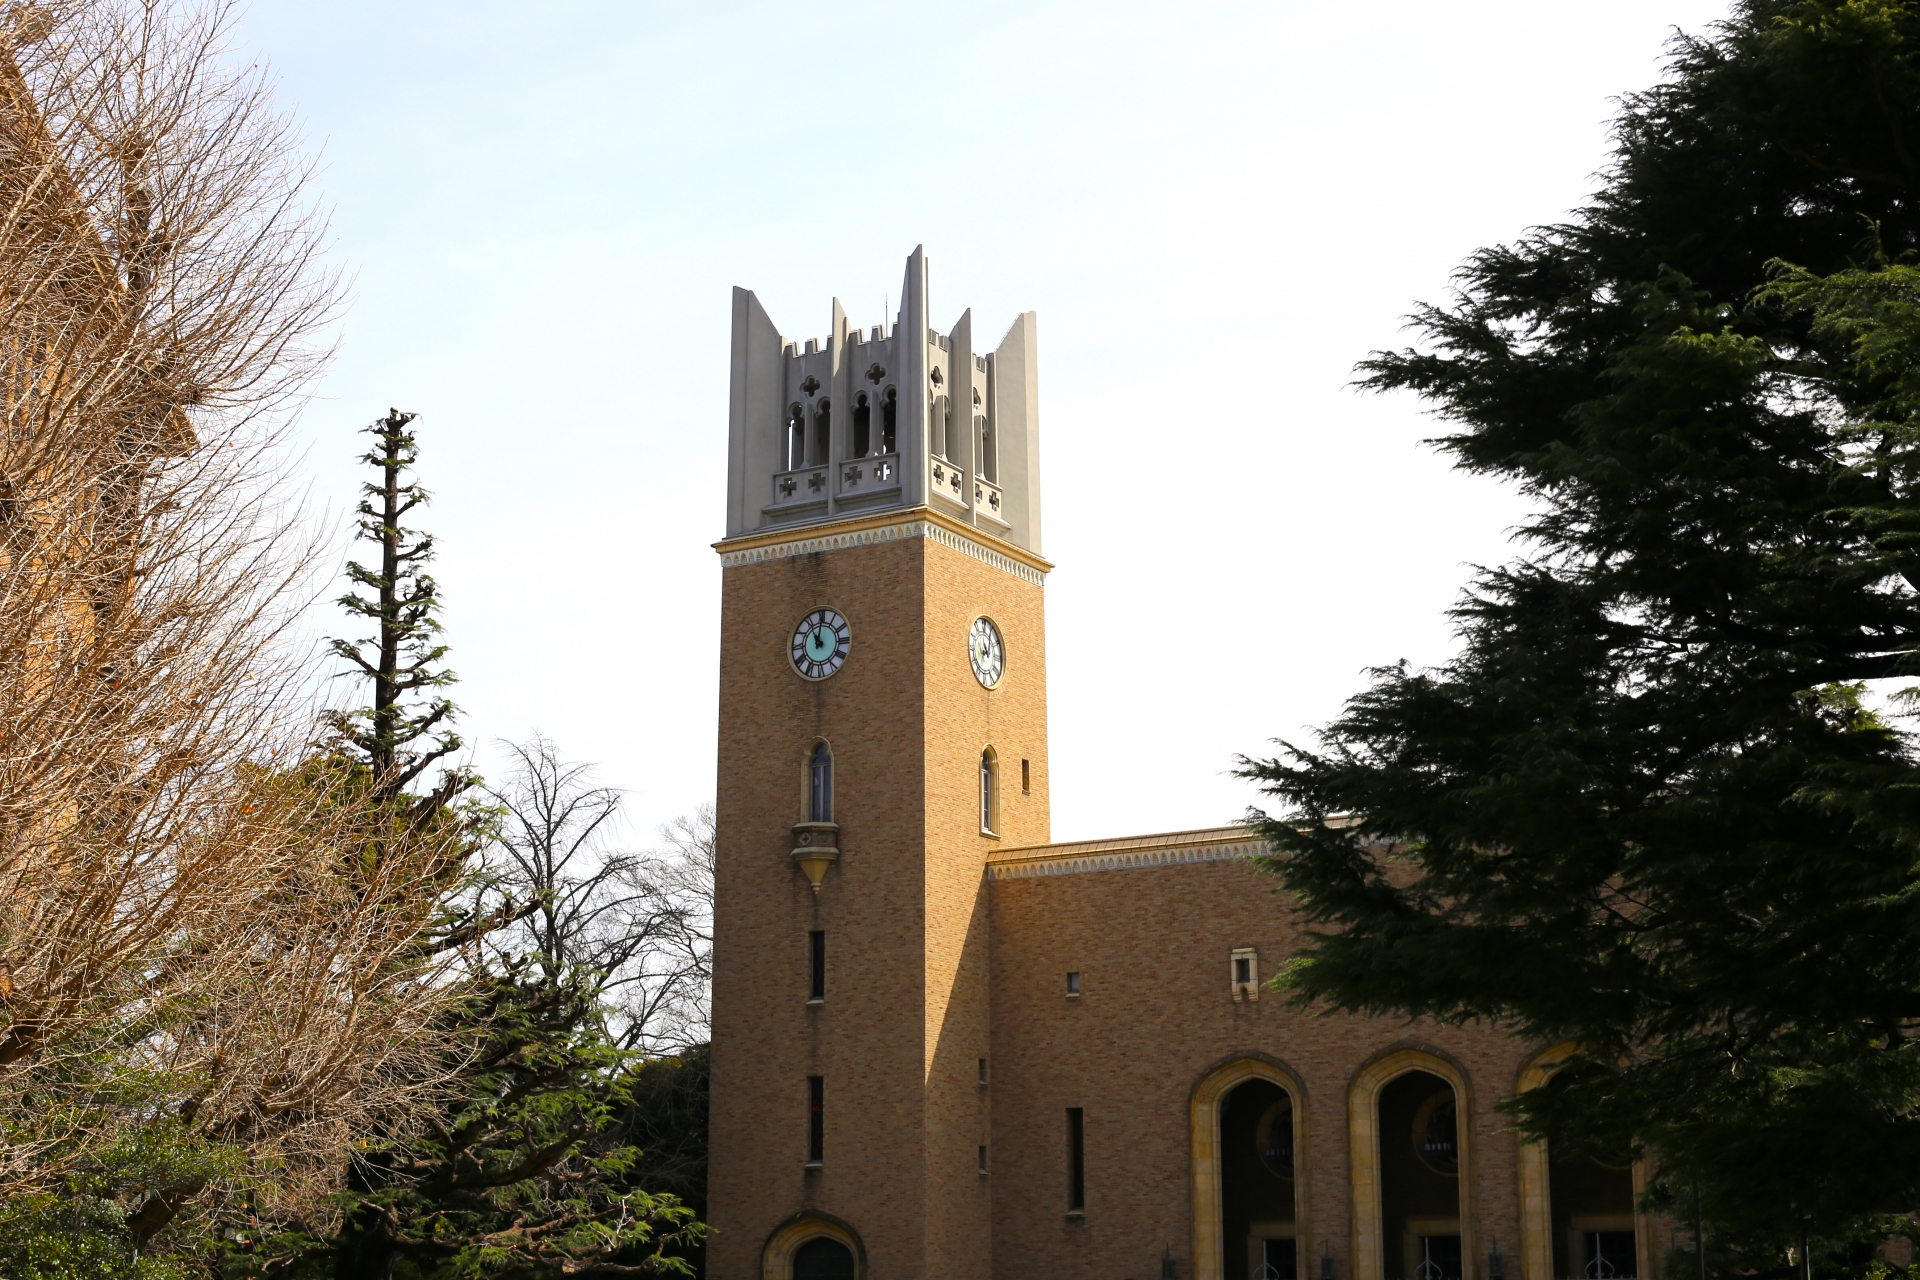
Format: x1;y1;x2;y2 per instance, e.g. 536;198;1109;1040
1242;0;1920;1274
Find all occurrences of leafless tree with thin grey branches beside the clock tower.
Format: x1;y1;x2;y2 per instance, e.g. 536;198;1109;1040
488;737;712;1054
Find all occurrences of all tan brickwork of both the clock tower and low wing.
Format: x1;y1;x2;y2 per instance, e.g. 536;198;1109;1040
708;521;1667;1280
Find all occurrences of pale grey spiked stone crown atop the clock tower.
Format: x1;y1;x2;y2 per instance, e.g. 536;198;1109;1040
726;248;1041;555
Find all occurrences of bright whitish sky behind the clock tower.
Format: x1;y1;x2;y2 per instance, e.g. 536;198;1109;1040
236;0;1726;841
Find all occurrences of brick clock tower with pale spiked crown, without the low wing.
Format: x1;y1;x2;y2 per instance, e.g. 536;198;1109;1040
708;249;1050;1280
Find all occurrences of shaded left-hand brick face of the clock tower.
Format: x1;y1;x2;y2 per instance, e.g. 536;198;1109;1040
708;541;924;1280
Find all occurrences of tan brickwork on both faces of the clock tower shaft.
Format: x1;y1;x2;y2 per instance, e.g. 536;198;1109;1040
708;521;1048;1280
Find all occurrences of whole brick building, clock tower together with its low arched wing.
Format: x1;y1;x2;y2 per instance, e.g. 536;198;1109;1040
708;249;1670;1280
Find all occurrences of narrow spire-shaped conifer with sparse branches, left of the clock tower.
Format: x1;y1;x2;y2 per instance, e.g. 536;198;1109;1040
332;409;474;816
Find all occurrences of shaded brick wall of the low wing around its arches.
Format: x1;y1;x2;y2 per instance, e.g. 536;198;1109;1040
991;862;1524;1280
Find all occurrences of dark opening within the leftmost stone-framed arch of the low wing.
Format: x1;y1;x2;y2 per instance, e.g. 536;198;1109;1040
1219;1079;1300;1280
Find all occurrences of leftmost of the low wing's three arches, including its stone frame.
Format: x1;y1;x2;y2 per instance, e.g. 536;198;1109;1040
1190;1055;1309;1280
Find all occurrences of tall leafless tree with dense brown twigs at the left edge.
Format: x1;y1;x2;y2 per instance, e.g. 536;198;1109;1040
0;0;467;1236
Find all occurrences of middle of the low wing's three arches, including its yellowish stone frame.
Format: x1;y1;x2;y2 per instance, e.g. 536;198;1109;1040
1348;1048;1475;1280
